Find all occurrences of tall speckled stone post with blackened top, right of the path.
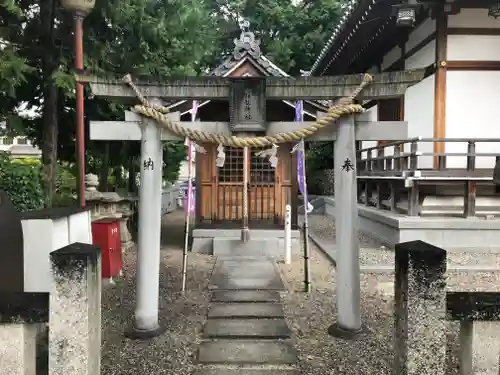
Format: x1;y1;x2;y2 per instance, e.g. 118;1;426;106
394;241;446;375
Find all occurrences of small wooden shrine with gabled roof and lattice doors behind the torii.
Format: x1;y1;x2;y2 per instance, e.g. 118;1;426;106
168;30;326;253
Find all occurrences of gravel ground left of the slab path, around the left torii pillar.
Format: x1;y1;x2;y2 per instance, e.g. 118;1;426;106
101;211;215;375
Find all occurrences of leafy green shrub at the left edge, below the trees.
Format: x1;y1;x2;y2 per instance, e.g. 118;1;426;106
0;152;44;212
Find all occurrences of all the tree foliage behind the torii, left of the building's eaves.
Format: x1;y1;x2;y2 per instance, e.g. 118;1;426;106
0;0;344;206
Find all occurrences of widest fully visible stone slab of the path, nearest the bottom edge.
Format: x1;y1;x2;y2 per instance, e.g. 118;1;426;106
198;340;297;365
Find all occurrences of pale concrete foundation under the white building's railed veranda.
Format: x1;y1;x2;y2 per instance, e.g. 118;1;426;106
317;197;500;253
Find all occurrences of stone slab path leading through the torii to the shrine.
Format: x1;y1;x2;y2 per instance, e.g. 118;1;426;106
195;256;299;375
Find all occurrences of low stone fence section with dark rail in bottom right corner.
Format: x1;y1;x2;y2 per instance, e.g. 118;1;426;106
446;292;500;375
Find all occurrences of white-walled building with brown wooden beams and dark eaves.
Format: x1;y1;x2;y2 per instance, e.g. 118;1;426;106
312;0;500;168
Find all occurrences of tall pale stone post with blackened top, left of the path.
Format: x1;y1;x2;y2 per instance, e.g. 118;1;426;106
49;242;101;375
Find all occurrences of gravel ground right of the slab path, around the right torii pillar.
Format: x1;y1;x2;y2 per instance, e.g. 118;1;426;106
279;245;393;375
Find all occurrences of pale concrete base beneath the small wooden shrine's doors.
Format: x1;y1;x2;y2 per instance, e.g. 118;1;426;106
191;229;300;258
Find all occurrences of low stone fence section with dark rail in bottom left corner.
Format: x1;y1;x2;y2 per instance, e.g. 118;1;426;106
0;292;49;375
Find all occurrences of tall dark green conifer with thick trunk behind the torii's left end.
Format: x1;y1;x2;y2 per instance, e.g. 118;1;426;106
0;0;217;204
